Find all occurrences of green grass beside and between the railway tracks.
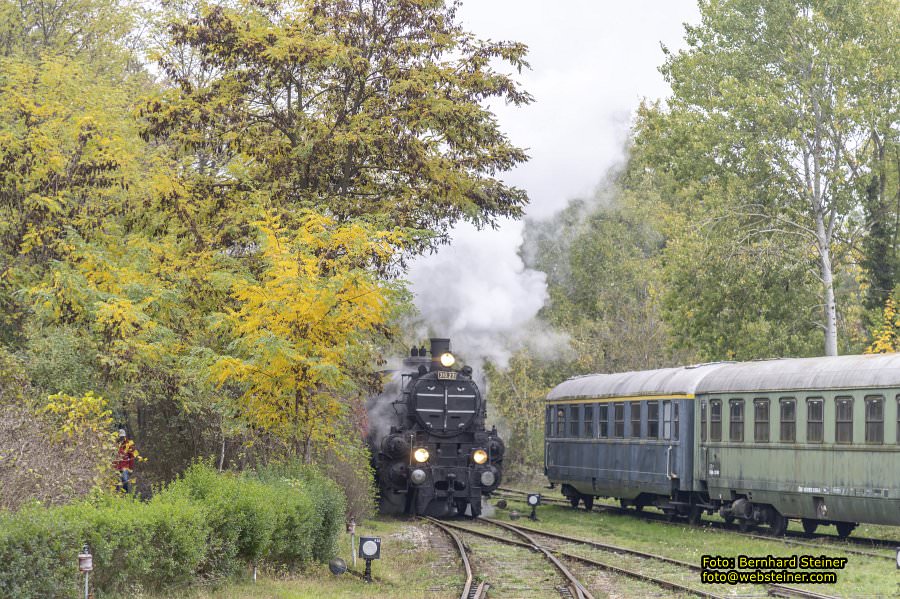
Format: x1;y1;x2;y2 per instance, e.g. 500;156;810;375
141;494;900;599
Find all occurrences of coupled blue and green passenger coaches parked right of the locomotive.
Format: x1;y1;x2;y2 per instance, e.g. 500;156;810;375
545;354;900;536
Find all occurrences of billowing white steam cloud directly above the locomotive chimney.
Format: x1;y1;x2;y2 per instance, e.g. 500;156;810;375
409;222;568;369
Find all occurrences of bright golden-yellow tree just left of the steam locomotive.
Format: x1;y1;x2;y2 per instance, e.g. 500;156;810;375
212;212;401;461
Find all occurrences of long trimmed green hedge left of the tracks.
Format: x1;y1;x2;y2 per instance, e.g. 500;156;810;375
0;464;345;599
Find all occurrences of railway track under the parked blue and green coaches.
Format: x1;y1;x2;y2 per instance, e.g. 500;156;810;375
498;488;900;561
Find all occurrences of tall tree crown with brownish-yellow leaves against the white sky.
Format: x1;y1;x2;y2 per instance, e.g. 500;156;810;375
141;0;531;252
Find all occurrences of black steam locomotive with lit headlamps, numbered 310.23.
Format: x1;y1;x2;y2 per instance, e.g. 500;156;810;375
370;339;504;517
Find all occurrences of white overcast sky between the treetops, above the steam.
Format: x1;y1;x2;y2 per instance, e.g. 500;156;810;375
460;0;699;217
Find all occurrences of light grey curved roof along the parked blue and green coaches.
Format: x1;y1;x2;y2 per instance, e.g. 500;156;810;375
547;354;900;401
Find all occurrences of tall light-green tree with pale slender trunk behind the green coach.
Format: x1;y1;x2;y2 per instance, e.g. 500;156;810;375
662;0;900;355
